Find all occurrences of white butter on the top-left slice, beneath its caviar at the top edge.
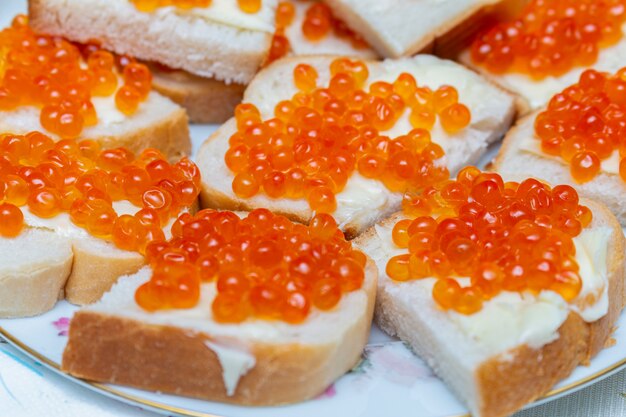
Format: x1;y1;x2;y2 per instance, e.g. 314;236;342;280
166;0;277;34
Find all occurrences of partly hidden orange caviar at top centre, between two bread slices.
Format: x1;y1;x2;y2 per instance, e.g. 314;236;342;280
268;0;369;62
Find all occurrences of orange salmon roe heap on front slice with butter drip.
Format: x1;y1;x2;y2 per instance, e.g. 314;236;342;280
135;209;366;323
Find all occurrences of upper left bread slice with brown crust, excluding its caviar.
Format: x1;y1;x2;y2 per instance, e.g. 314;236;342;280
0;91;191;159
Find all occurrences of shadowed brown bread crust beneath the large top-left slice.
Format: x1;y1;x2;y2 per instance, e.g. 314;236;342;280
150;65;246;123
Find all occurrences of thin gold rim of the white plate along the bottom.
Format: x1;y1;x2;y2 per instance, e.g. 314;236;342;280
0;327;626;417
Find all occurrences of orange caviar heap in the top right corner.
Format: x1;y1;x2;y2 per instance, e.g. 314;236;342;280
471;0;626;80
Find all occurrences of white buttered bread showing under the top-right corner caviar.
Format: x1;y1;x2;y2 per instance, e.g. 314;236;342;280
459;20;626;114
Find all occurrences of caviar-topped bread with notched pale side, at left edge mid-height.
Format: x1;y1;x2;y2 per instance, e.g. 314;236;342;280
0;132;200;316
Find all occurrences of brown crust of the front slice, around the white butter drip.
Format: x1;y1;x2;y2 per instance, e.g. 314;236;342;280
62;260;377;405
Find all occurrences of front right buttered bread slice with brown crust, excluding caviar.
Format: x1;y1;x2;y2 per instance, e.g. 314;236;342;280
355;199;625;417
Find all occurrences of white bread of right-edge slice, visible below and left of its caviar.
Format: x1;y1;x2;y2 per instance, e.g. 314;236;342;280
493;112;626;226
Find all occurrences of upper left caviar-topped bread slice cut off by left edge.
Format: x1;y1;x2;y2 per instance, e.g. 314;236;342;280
0;16;191;157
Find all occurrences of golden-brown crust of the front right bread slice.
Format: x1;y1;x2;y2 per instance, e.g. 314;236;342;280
355;199;625;417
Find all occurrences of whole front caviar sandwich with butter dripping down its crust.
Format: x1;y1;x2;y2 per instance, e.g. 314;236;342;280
63;209;377;405
